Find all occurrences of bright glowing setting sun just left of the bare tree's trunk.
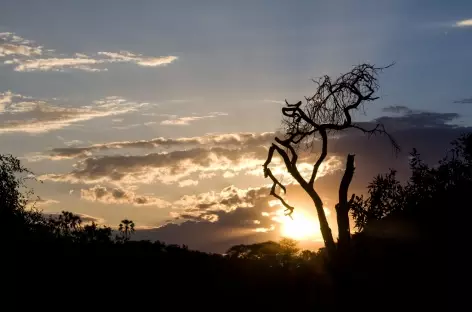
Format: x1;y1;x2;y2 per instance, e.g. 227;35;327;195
281;211;320;240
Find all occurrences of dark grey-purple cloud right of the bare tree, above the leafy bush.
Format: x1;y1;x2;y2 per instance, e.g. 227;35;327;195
323;107;466;193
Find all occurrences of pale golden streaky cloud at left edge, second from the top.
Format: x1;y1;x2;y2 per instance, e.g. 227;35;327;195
0;91;149;134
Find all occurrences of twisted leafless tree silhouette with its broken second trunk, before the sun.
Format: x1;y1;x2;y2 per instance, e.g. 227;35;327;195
264;64;399;256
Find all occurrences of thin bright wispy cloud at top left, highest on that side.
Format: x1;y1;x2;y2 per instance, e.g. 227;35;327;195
0;33;178;72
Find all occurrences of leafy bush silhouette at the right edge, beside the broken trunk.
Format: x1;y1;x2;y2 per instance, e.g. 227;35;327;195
351;134;472;244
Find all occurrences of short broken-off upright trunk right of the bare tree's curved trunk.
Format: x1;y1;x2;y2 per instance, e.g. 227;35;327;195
336;154;354;251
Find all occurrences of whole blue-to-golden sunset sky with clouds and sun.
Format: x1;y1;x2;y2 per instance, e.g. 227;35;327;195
0;0;472;252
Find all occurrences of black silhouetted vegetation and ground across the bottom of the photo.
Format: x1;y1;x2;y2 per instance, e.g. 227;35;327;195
0;135;458;310
